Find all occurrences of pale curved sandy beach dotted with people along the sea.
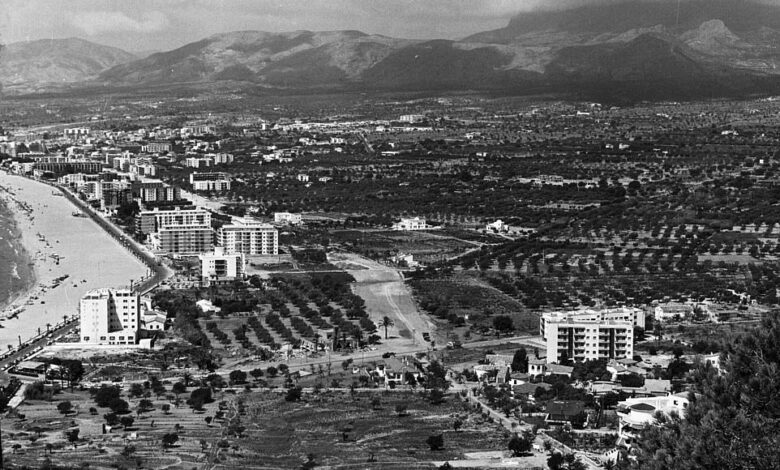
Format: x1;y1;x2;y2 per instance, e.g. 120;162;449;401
0;173;149;351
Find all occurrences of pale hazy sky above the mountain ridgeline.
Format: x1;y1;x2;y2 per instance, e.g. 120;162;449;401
0;0;532;51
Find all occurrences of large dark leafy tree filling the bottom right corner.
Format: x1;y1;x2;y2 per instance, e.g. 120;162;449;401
635;315;780;470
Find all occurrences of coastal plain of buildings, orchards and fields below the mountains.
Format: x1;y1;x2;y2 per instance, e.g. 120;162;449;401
0;96;780;469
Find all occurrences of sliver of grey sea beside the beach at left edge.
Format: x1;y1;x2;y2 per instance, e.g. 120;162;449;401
0;199;35;310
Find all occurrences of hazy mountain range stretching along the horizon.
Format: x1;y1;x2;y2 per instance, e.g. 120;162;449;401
0;0;780;99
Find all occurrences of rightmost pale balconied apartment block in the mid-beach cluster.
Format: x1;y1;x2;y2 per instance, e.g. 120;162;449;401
217;217;279;256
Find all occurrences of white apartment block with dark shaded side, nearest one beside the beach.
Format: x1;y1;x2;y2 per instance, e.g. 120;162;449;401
79;288;141;345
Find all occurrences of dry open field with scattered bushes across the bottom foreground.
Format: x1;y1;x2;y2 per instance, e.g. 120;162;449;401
3;387;509;469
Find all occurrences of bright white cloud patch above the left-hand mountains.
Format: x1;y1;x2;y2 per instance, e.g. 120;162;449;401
70;11;169;36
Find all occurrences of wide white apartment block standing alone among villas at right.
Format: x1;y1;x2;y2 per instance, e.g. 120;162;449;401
539;308;644;363
